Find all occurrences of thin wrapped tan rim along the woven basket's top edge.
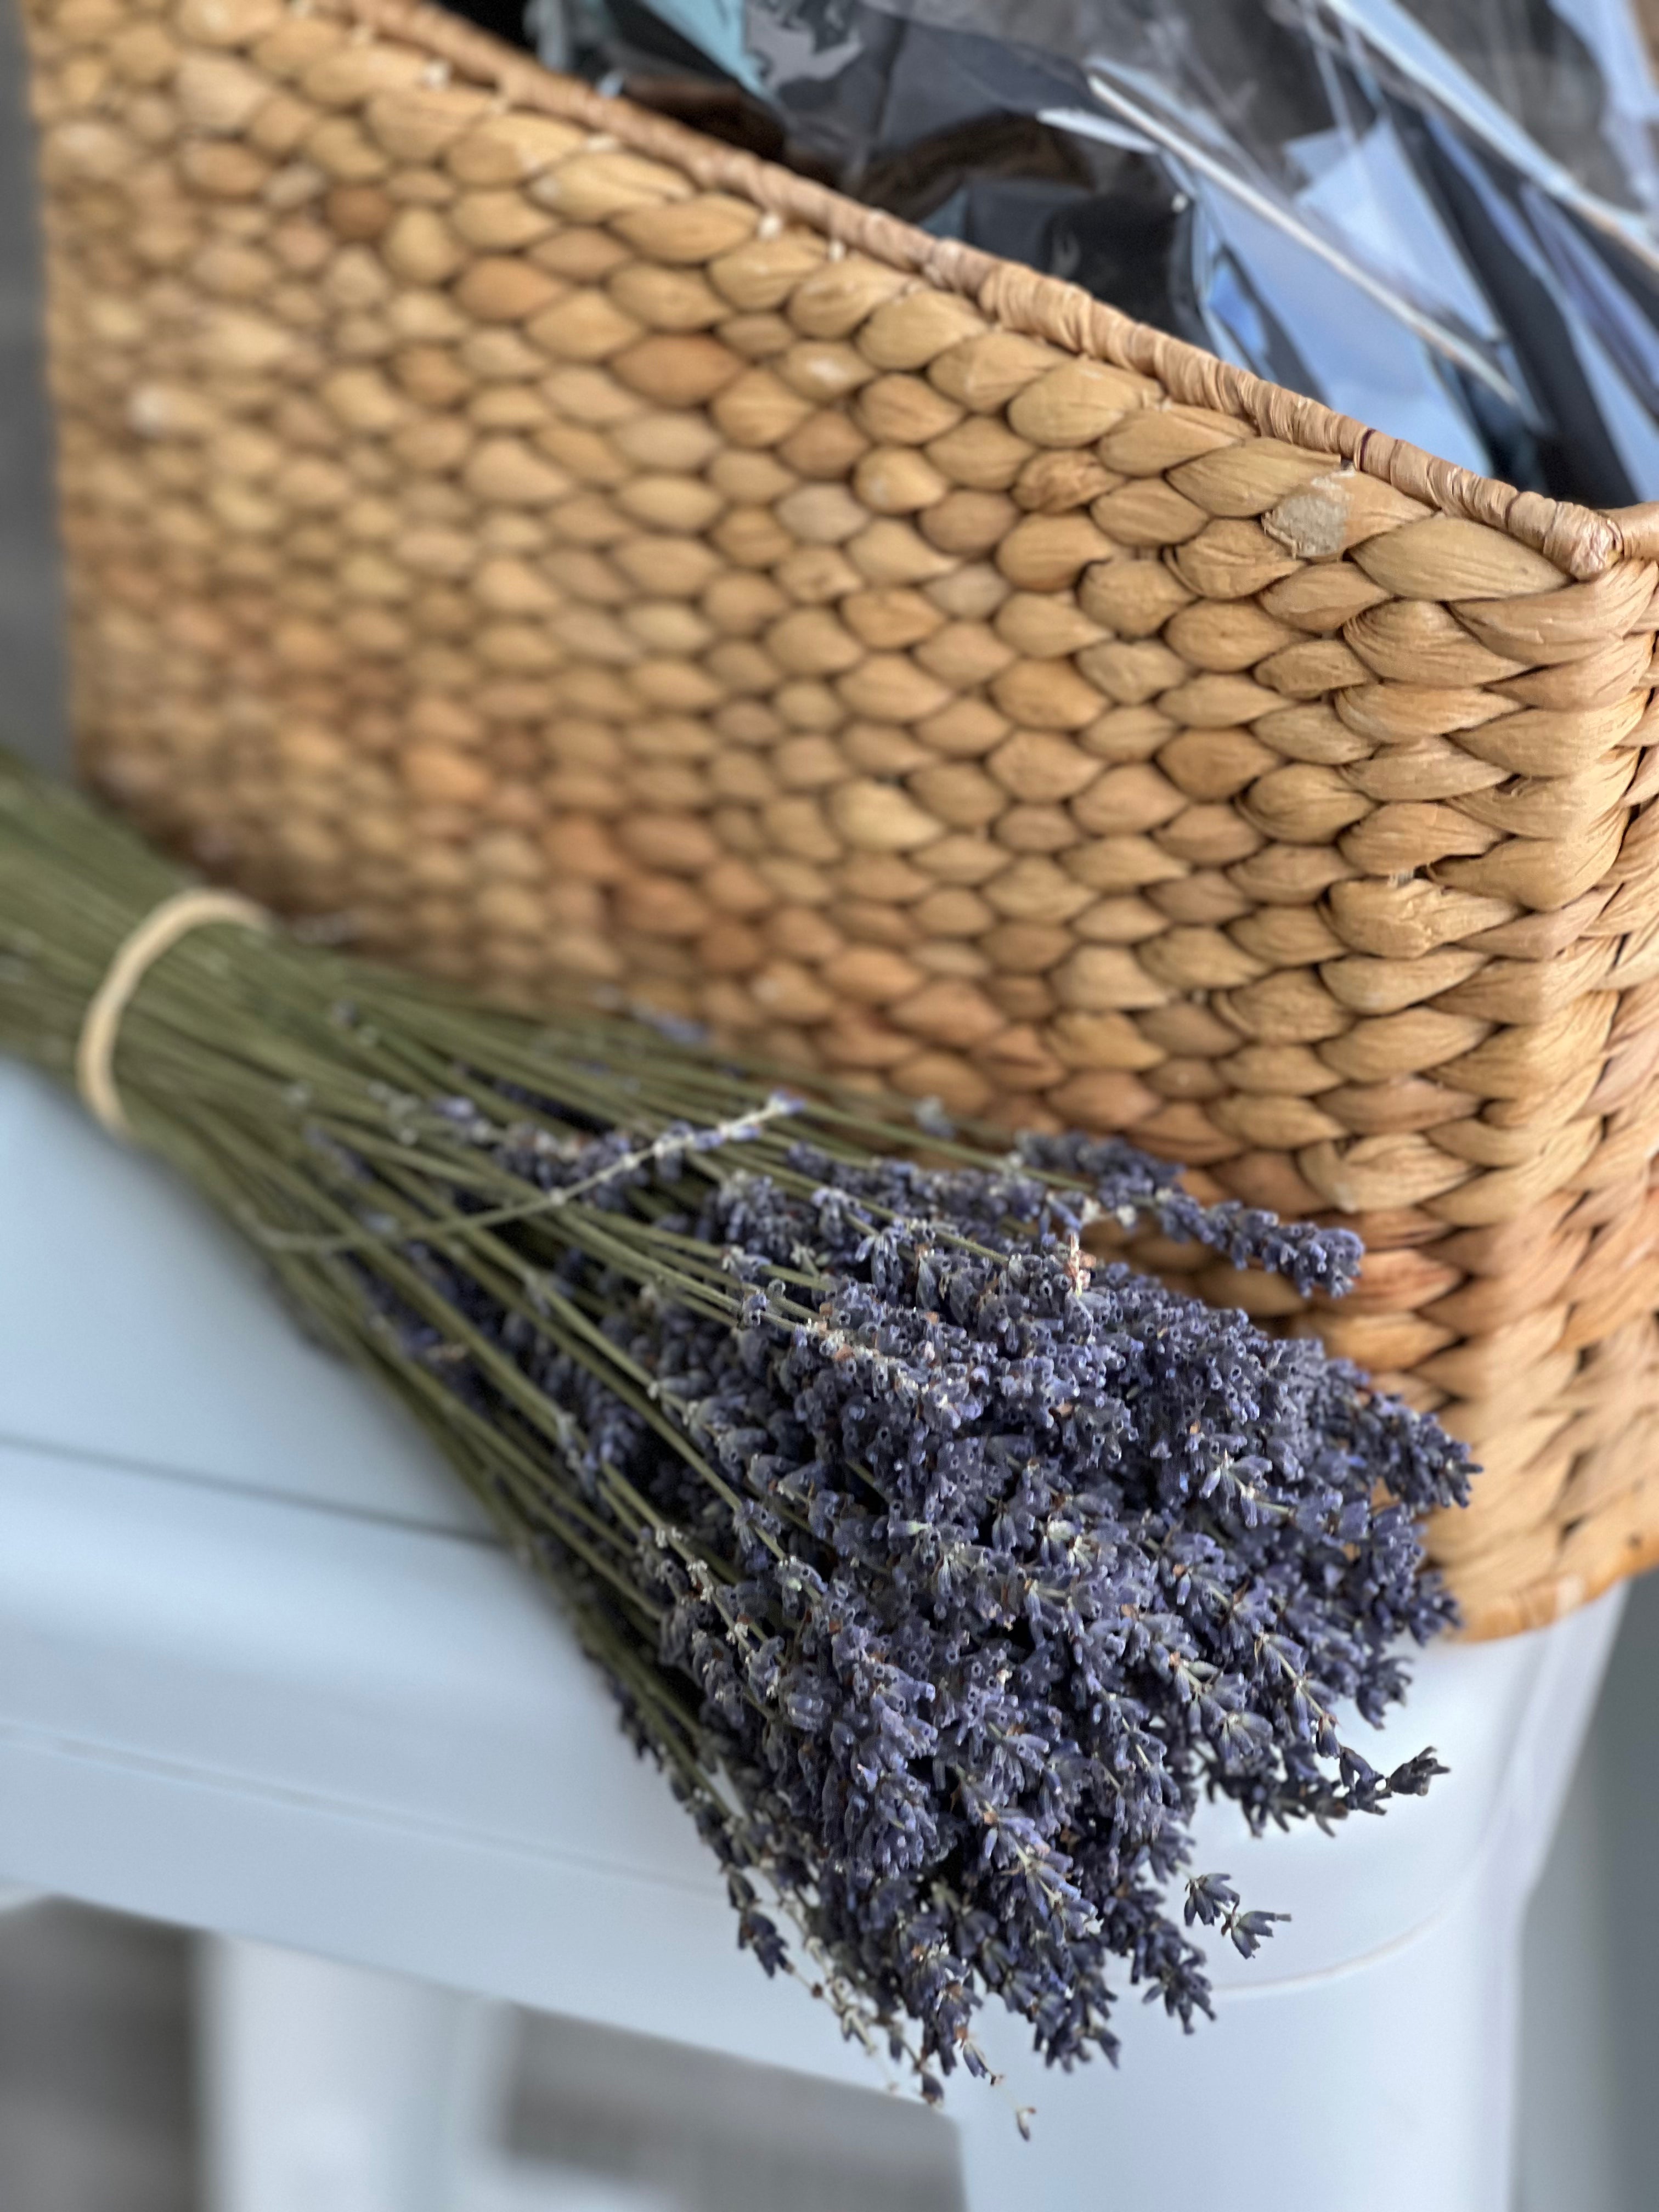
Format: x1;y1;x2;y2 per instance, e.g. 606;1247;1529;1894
327;0;1659;582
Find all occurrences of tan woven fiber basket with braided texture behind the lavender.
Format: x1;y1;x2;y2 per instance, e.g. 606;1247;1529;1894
29;0;1659;1635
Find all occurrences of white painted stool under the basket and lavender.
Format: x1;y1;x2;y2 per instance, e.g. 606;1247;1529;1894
0;1066;1617;2212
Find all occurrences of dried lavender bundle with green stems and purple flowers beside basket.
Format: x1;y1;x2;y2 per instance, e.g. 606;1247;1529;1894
0;765;1469;2095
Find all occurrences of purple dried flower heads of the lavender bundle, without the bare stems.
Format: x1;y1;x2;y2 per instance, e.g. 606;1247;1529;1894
352;1128;1466;2073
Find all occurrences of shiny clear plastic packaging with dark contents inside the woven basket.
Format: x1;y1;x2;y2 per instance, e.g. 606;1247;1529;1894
465;0;1659;506
